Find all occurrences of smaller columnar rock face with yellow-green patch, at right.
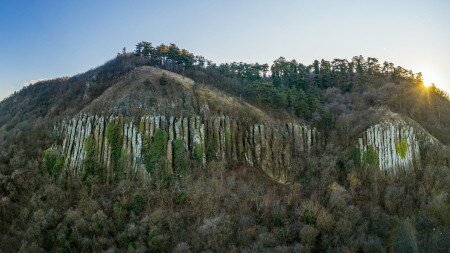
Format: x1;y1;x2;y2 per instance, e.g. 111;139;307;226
358;120;437;172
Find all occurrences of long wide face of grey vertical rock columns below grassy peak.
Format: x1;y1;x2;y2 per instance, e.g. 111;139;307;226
57;114;320;182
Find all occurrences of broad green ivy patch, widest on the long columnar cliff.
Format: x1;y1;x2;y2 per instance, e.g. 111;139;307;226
144;128;168;180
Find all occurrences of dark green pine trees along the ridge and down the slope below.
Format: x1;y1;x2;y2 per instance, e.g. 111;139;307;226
134;41;430;125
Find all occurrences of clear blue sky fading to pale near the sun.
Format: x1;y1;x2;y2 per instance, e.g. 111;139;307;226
0;0;450;99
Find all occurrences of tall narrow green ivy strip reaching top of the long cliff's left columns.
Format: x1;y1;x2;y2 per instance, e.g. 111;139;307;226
106;122;124;180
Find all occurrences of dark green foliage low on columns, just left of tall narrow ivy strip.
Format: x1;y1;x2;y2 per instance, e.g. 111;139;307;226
81;136;102;183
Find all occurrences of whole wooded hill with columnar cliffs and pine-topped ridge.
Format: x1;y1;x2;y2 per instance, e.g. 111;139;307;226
0;42;450;252
